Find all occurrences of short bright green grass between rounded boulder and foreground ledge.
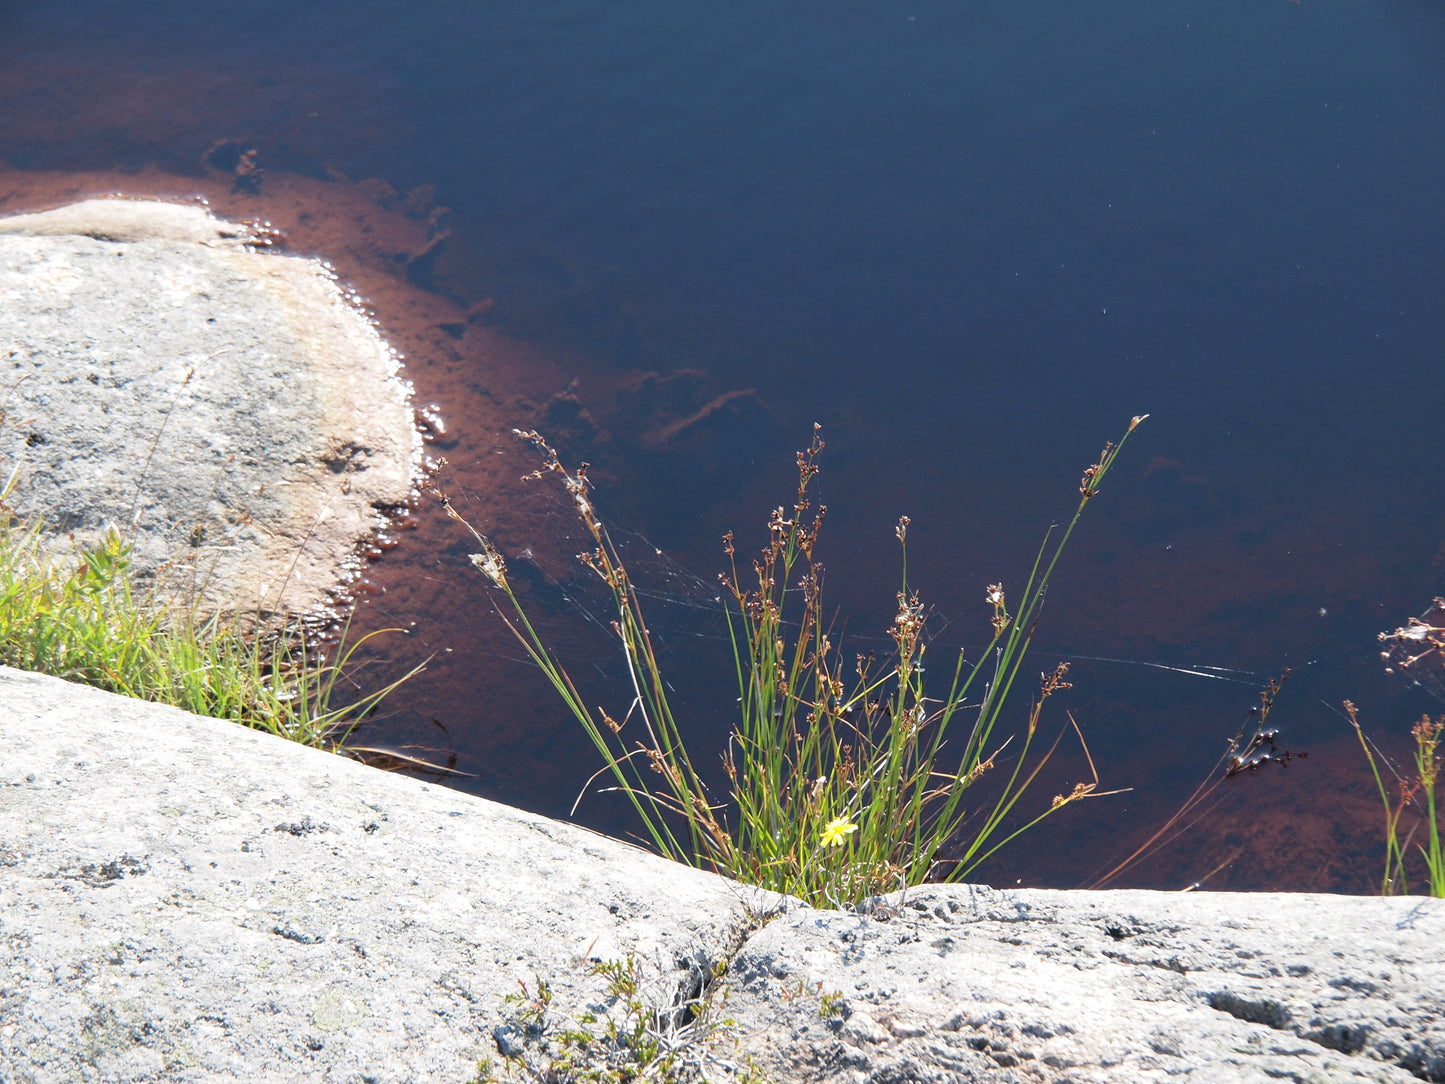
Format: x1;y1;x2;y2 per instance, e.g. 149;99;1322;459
0;500;420;749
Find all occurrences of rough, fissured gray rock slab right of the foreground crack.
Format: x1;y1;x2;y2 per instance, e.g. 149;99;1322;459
728;886;1445;1084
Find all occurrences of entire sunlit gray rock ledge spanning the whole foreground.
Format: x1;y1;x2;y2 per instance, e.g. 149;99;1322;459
0;669;1445;1083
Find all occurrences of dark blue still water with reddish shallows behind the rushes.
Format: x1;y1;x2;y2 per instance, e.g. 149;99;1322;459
0;0;1445;890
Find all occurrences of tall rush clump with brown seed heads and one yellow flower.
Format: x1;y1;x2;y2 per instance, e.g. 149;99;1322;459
442;416;1143;906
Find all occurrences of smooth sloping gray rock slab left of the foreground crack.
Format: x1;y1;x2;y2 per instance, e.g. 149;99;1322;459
0;668;768;1084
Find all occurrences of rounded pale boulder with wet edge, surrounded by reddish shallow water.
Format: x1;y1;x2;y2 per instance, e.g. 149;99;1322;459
0;199;420;613
